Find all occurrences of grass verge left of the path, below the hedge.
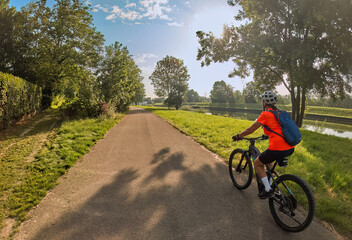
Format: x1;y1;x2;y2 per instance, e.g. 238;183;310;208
0;111;123;237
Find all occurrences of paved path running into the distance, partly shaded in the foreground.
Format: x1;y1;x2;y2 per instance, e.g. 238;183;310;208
15;108;337;240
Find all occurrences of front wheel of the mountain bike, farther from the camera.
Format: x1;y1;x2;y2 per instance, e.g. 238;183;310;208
229;149;253;189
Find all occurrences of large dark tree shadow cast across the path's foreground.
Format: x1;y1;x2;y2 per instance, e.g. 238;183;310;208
33;148;336;240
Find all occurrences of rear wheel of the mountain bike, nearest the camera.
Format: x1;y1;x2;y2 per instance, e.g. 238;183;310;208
269;174;315;232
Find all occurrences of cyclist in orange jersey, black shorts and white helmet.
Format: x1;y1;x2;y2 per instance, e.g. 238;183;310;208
232;91;294;199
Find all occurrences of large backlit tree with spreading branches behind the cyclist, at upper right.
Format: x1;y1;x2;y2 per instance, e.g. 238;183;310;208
197;0;352;126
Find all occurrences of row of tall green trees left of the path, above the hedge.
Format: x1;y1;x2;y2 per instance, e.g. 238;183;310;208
0;0;145;115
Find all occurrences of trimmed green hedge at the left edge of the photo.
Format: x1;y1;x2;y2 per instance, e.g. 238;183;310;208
0;72;42;128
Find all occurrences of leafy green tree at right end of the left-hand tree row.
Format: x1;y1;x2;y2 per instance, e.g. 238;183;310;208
97;42;142;111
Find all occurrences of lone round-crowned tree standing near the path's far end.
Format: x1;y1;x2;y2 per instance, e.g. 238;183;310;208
149;56;190;109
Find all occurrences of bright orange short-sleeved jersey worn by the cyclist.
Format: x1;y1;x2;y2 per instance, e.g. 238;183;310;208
257;108;292;151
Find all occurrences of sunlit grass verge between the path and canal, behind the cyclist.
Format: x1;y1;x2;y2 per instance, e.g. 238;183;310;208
145;107;352;238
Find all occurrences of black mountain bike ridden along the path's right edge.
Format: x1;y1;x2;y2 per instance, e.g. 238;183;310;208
229;135;315;232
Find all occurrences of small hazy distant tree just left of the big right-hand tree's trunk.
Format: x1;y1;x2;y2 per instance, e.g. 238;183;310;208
210;80;235;103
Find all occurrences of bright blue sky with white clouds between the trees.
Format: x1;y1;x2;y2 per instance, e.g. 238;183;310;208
10;0;258;98
